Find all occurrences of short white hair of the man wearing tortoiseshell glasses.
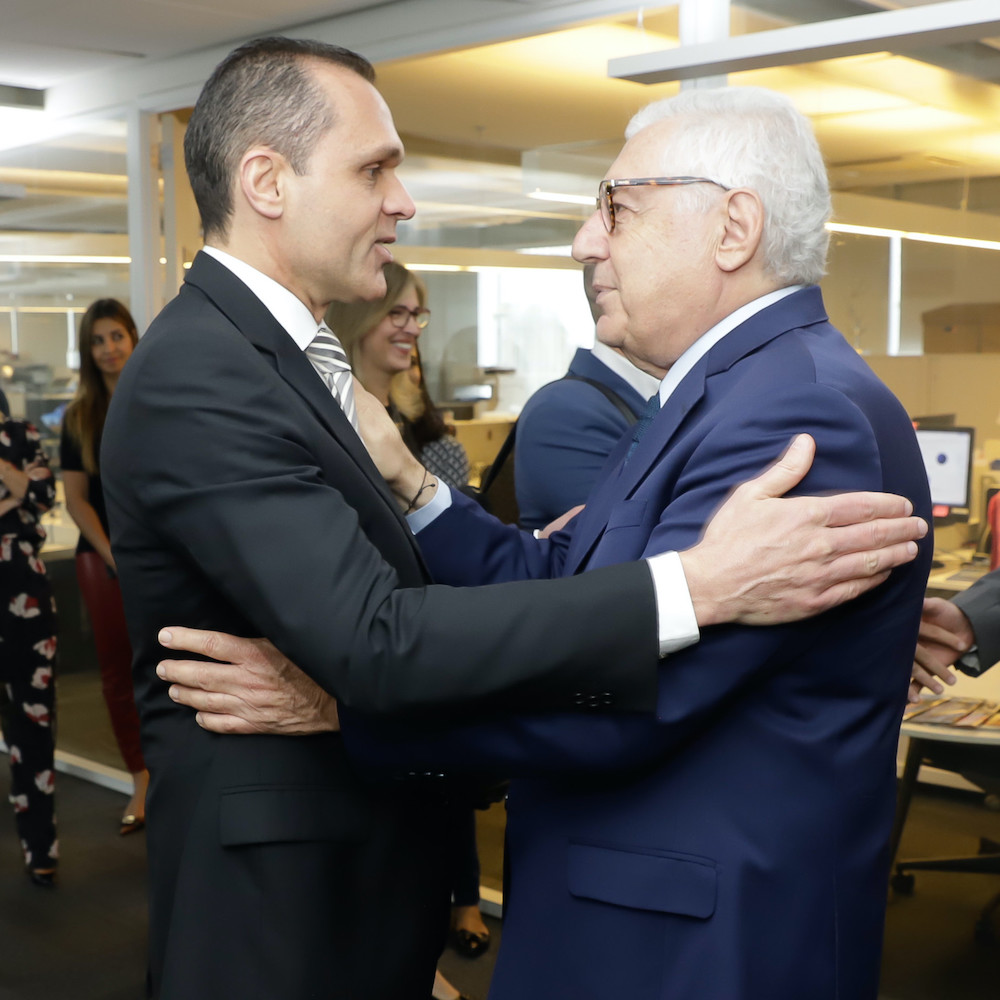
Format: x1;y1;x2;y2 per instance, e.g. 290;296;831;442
625;87;831;285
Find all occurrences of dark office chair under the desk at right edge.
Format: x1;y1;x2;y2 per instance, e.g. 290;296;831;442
889;736;1000;944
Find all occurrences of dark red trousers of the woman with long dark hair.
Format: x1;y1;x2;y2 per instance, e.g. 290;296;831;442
76;552;146;774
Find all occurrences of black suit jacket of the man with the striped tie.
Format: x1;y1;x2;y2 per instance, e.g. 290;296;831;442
102;254;657;1000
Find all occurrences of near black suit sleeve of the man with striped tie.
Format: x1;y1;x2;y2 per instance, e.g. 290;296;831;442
105;328;658;712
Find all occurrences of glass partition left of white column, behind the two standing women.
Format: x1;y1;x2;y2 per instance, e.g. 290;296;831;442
0;115;135;772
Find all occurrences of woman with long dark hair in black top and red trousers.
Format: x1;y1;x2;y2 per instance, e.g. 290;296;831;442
59;299;149;835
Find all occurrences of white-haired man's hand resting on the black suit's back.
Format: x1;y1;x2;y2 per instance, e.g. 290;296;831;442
156;626;340;736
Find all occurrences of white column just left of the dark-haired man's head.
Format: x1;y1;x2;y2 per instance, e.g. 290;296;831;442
127;107;163;334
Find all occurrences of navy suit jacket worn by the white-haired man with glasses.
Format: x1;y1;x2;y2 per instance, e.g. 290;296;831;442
346;288;930;1000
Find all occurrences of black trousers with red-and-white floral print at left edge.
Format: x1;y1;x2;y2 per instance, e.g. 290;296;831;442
0;535;59;868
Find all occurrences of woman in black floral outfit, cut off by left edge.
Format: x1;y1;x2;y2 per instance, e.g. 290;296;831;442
0;399;59;888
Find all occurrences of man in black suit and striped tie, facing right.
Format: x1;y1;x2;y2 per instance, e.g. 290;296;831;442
101;39;919;1000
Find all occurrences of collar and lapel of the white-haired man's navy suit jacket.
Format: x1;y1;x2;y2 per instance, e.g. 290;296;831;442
565;287;827;574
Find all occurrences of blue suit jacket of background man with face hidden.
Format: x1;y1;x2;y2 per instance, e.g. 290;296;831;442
514;347;646;529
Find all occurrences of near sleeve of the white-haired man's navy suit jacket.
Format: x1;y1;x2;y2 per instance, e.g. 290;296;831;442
343;385;900;776
